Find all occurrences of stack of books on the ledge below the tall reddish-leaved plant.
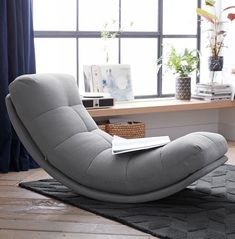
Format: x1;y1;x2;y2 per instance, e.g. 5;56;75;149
192;84;232;101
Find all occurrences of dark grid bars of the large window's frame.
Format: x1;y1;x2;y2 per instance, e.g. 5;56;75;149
34;0;202;99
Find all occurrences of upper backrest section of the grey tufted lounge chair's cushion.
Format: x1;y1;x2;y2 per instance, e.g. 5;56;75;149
9;74;100;159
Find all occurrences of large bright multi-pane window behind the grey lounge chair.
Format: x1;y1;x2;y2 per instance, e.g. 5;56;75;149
33;0;200;98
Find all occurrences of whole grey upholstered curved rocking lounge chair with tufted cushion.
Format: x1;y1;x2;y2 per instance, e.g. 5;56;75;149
6;74;227;202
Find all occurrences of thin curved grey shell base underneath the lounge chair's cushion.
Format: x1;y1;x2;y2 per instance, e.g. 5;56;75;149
6;95;227;203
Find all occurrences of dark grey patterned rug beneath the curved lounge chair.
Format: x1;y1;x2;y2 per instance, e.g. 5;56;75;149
19;164;235;239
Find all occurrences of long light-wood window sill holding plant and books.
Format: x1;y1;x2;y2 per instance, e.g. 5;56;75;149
88;99;235;117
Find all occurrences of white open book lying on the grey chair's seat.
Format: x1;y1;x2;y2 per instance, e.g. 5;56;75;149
112;135;171;154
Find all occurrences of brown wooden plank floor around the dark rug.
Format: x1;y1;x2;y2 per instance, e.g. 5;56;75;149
0;142;235;239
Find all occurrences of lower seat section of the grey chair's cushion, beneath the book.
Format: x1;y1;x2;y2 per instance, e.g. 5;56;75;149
48;132;227;195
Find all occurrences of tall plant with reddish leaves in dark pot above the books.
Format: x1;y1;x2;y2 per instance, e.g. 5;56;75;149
196;0;235;71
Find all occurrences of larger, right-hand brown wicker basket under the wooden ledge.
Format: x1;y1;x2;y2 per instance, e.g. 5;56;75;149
106;121;145;139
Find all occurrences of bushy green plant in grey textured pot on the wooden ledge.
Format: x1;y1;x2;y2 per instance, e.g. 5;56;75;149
162;46;199;100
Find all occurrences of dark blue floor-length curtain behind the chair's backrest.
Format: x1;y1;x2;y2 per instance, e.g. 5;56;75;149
0;0;37;173
